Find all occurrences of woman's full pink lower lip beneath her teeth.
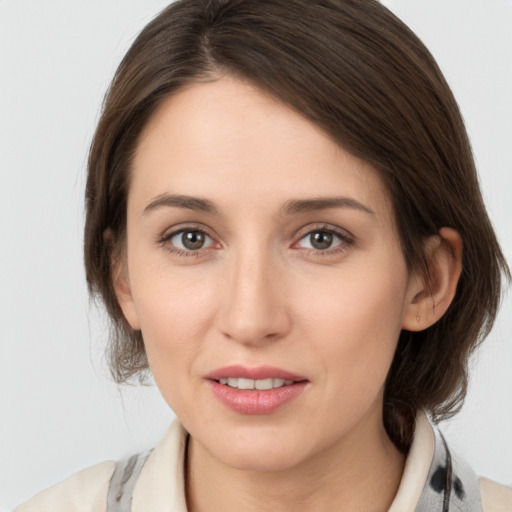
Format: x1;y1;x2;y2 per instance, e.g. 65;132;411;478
208;380;307;414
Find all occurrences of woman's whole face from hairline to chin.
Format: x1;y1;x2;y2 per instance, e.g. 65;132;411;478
116;78;419;469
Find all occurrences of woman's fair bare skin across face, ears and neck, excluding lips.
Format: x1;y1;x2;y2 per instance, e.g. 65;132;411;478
114;77;462;512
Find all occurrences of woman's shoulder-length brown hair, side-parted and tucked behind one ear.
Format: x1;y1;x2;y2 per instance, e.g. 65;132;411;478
85;0;510;449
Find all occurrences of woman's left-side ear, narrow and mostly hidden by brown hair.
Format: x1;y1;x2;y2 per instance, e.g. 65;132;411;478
103;230;140;331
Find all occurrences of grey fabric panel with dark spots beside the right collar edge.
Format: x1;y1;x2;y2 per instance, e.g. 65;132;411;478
415;428;482;512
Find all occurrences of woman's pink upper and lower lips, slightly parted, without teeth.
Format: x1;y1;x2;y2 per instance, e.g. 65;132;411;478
205;365;309;415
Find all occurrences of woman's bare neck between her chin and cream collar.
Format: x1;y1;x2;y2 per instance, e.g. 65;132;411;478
186;404;404;512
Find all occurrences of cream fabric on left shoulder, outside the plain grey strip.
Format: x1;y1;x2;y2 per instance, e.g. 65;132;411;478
14;461;116;512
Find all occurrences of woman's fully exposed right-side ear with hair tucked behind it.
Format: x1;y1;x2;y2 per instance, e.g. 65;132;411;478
402;228;462;331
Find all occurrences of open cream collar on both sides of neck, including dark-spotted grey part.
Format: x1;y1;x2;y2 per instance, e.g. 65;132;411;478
123;411;482;512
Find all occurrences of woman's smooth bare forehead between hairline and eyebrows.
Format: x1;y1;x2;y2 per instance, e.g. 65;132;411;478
129;77;390;217
